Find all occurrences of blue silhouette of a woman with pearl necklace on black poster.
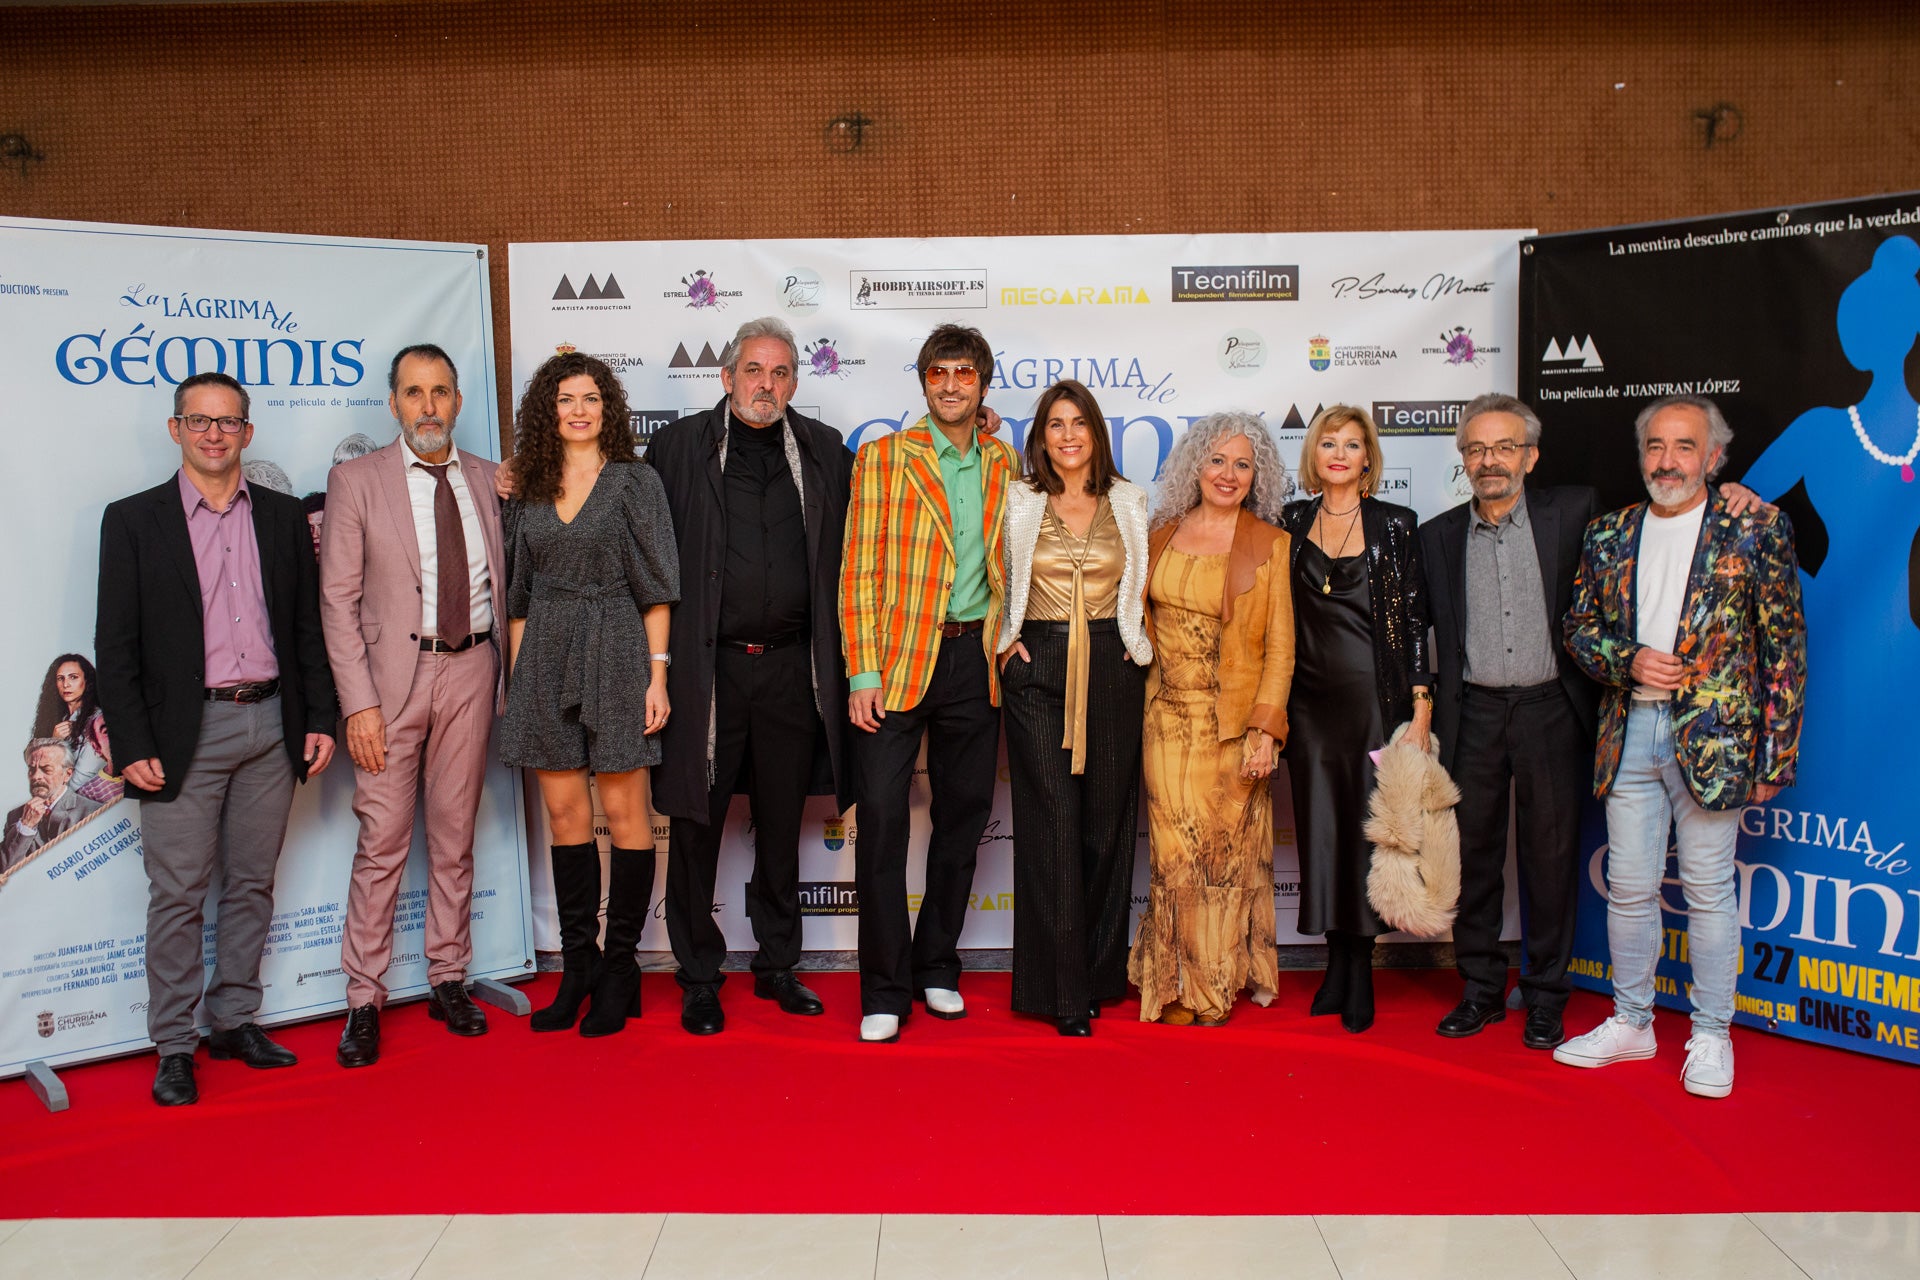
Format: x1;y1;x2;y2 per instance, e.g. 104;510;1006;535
1743;236;1920;821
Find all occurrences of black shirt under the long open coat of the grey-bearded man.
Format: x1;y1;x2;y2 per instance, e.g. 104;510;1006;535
720;413;812;645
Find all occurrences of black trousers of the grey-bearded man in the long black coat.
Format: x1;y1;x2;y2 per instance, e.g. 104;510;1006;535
666;641;824;990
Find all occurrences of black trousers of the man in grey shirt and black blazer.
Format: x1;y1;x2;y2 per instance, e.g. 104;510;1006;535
1453;681;1594;1009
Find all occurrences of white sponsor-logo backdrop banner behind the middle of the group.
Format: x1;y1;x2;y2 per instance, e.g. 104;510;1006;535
509;230;1528;950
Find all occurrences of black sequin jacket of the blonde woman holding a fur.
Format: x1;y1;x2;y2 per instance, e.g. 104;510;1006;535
1281;497;1432;733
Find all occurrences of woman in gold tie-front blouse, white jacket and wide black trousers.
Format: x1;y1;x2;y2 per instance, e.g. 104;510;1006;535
1000;380;1152;1036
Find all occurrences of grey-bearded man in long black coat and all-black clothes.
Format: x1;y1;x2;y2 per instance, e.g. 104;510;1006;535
647;317;852;1036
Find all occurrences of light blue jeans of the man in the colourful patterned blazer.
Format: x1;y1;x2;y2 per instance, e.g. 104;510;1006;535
1607;702;1740;1036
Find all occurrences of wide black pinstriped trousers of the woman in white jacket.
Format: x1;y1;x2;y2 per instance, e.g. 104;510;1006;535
1000;618;1146;1017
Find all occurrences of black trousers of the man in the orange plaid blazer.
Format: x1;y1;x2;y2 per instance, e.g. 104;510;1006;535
852;631;1000;1017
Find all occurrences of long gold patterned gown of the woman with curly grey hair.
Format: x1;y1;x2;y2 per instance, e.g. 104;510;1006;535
1127;547;1279;1021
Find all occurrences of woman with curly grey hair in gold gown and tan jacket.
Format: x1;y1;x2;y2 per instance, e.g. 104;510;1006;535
1129;413;1294;1027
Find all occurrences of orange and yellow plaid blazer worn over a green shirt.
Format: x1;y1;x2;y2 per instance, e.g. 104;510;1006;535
839;416;1020;712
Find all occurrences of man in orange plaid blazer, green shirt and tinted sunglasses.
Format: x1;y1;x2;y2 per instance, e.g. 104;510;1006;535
839;324;1020;1042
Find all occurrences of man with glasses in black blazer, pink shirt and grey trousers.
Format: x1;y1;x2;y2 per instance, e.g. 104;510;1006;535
94;374;336;1107
